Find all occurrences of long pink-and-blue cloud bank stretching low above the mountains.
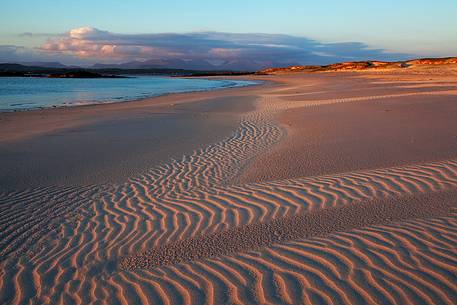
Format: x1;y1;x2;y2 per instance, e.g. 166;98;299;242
0;27;409;69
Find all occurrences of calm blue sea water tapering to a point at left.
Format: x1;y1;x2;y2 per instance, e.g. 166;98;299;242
0;76;257;111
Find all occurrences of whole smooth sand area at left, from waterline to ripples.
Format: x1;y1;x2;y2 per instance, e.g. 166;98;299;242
0;76;278;190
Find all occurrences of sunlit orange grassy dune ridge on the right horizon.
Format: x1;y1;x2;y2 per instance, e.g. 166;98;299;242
256;57;457;74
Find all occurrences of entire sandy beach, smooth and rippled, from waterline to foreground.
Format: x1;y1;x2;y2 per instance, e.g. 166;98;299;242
0;66;457;305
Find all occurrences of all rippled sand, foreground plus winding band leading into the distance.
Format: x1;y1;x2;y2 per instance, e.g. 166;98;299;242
0;70;457;304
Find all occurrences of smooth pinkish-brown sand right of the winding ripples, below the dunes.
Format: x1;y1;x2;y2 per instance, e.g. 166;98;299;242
241;73;457;183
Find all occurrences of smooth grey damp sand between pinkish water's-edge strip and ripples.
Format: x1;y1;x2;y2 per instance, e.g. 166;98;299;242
0;96;256;190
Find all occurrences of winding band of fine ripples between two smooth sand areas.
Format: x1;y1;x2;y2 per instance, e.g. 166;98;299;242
131;98;284;198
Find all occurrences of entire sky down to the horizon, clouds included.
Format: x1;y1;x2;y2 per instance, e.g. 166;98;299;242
0;0;457;66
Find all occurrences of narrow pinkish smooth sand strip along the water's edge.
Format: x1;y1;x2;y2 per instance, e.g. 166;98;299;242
0;76;274;143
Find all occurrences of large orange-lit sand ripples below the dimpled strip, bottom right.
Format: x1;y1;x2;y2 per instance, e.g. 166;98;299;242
131;214;457;304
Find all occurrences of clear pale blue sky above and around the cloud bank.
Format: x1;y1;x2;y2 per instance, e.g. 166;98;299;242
0;0;457;67
